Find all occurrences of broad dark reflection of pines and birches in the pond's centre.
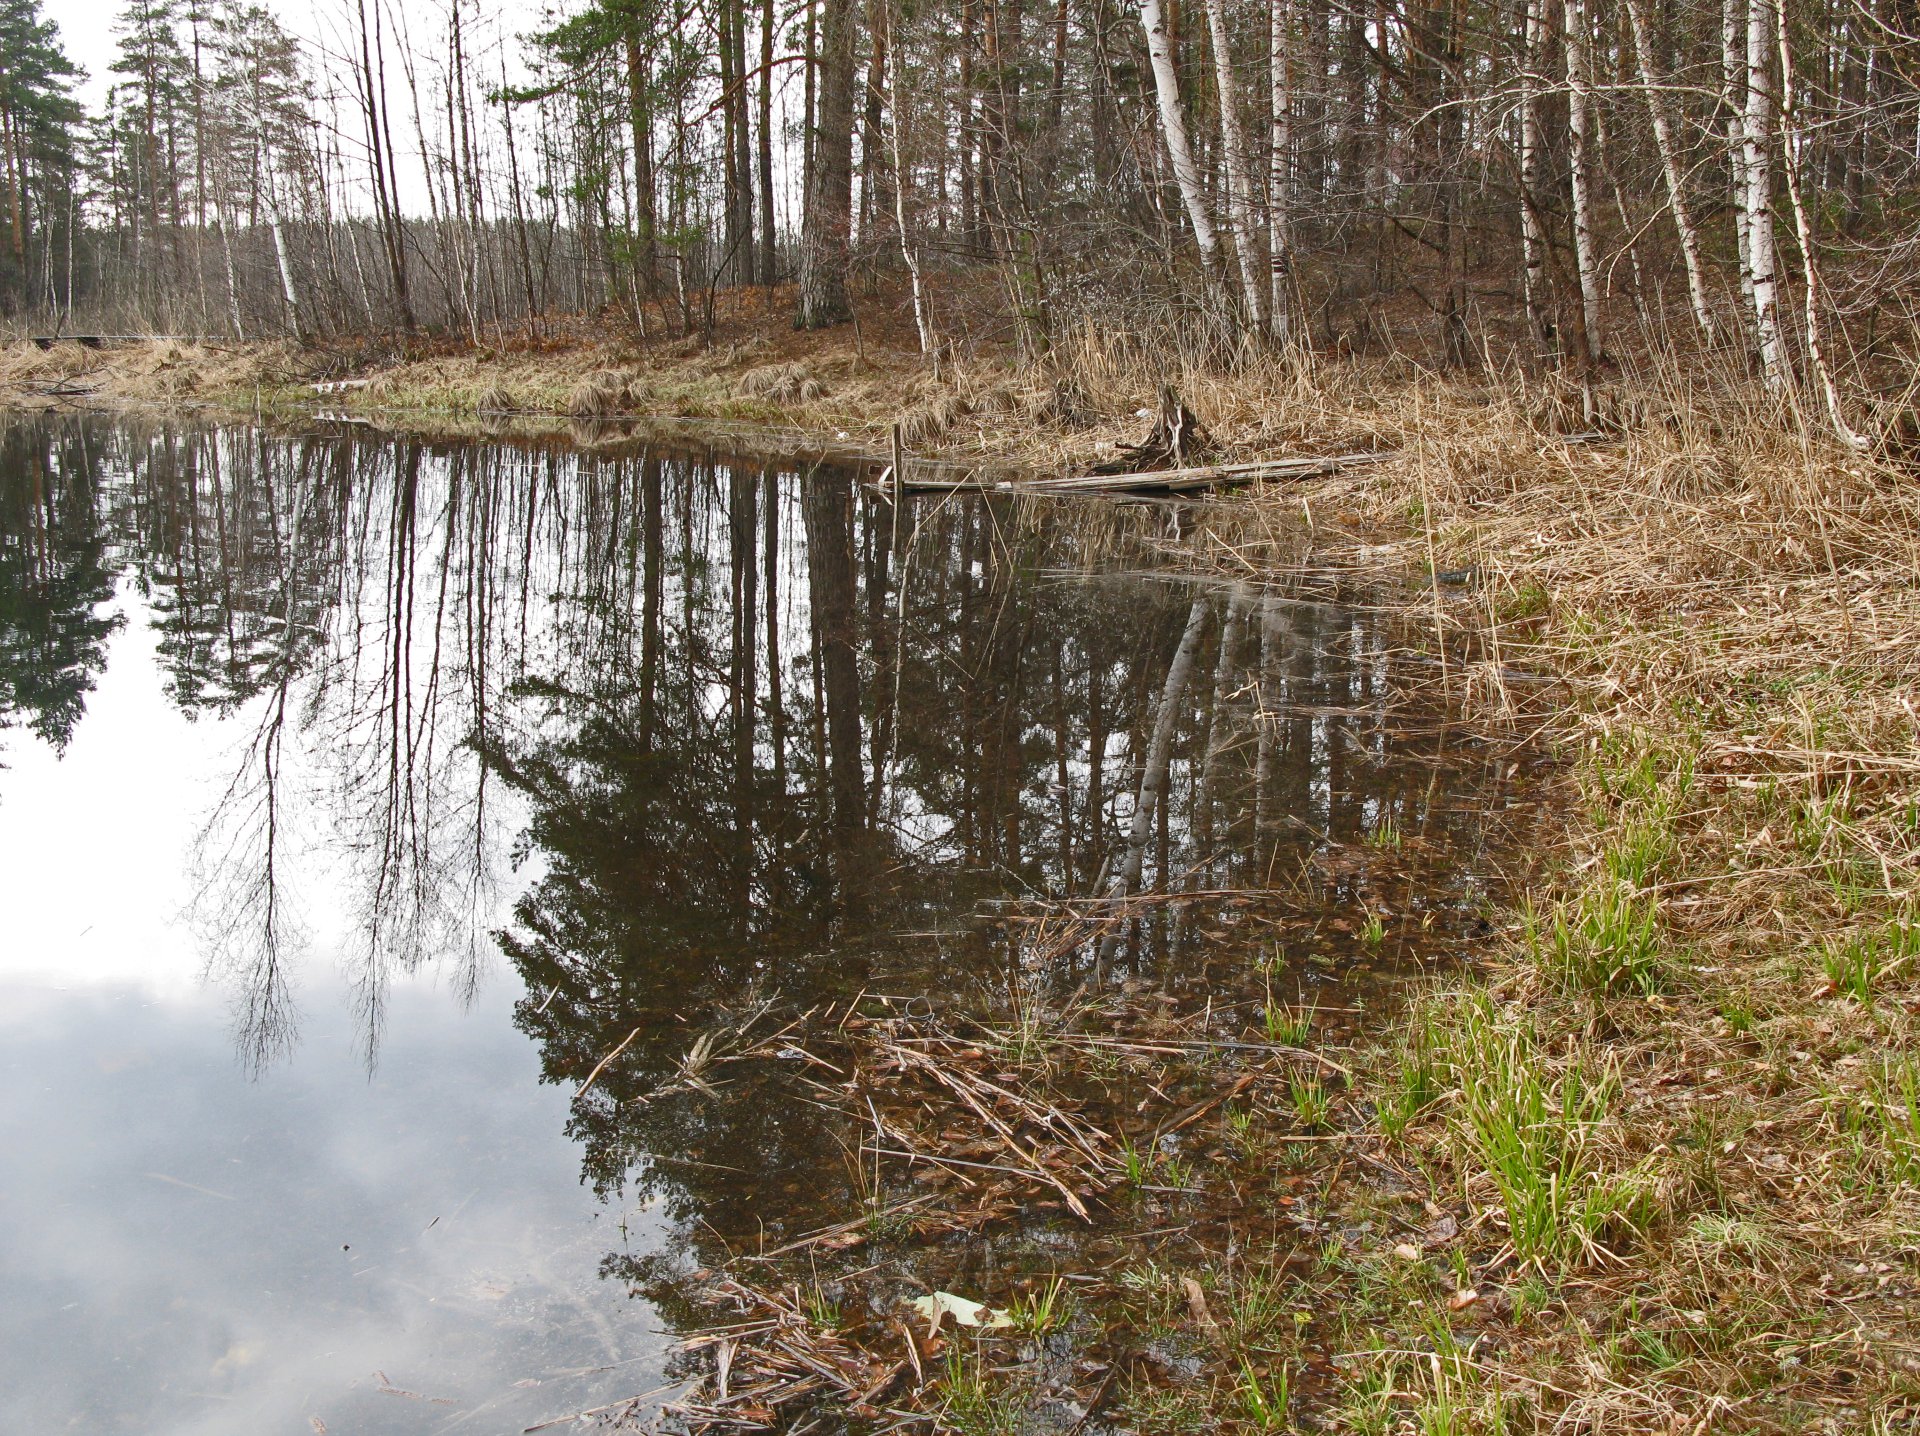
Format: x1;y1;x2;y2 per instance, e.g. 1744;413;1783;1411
488;461;1528;1234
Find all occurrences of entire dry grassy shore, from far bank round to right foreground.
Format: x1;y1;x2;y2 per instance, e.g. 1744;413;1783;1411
0;286;1920;1436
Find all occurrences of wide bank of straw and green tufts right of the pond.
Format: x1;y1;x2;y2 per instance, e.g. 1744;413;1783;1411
1198;364;1920;1432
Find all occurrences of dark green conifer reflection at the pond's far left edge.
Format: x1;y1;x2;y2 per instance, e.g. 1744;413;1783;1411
0;424;119;751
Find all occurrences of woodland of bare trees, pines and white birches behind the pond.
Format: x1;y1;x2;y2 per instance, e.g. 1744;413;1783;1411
0;0;1920;408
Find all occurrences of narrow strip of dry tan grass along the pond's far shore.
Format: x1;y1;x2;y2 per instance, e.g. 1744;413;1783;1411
0;292;1505;472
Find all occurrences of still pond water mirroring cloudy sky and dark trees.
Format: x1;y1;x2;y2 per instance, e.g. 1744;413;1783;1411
0;417;1538;1432
